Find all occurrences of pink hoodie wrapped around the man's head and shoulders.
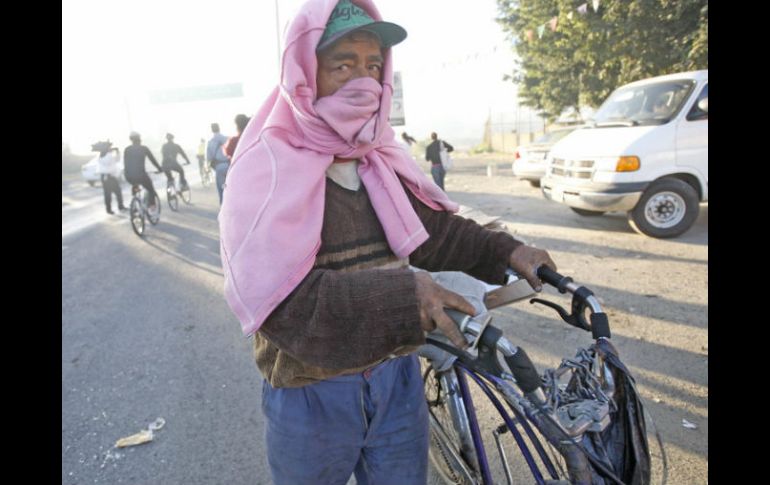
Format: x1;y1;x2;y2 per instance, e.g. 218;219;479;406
219;0;457;336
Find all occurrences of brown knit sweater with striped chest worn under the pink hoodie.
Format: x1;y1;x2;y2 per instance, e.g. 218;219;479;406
254;178;521;387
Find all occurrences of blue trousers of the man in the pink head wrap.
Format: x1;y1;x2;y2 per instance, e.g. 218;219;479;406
262;355;428;485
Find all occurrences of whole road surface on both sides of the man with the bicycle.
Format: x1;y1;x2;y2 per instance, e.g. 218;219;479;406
62;157;708;485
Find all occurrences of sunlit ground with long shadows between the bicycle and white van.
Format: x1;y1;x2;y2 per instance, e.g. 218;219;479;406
421;155;708;484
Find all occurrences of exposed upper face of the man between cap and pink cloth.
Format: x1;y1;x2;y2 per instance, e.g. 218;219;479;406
316;32;384;98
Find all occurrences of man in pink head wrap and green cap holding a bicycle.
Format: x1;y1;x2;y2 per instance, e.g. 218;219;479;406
219;0;555;485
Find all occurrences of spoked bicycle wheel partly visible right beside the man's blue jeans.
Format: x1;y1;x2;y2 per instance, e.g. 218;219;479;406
420;359;481;485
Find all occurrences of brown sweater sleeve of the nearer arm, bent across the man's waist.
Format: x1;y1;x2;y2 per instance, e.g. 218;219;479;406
259;269;425;369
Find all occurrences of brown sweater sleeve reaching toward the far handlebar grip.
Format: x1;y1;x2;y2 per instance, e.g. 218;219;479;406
405;189;523;285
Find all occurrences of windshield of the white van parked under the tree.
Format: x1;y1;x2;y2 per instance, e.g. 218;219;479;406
593;80;695;126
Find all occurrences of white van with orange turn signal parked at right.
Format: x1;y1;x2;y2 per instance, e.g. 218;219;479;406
540;70;708;238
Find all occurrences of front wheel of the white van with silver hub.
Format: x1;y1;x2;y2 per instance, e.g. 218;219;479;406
628;178;699;238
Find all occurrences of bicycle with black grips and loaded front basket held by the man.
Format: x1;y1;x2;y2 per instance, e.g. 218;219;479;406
419;267;668;485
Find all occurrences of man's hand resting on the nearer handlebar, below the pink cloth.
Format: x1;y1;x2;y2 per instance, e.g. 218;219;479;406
414;271;476;349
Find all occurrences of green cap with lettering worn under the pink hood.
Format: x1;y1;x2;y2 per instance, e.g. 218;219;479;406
316;0;406;50
